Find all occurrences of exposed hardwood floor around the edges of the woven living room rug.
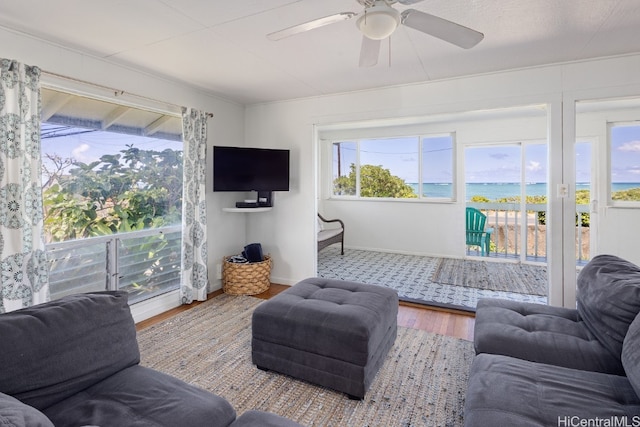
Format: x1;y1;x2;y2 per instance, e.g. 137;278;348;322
136;283;475;341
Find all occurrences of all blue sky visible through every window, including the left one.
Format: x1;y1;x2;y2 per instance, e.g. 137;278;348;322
42;125;640;183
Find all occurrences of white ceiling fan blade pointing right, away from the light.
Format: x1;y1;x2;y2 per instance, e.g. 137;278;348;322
401;9;484;49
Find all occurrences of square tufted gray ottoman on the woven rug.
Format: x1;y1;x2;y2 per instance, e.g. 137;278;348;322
251;278;398;399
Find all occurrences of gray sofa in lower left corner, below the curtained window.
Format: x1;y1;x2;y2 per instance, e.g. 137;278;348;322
0;292;298;427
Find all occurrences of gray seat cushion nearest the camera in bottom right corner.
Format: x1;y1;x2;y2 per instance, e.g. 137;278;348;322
464;353;640;427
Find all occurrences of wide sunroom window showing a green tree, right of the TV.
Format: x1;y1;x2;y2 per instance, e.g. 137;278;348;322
332;134;454;200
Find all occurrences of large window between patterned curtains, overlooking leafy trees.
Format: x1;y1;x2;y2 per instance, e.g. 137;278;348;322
41;89;183;302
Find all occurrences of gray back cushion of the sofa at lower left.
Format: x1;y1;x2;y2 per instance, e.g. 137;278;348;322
0;292;140;410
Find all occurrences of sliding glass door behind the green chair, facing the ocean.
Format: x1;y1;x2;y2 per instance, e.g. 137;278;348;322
465;141;548;263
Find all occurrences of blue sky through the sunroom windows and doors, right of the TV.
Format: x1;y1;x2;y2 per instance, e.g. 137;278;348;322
334;125;640;183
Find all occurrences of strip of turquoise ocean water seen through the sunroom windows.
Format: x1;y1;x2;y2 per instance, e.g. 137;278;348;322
409;182;640;201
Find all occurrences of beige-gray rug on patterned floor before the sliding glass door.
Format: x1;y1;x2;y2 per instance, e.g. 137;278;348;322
431;258;548;296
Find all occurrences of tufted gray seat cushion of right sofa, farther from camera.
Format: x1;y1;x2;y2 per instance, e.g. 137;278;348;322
474;298;624;375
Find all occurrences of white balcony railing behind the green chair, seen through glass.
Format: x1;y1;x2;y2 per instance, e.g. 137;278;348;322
467;203;590;264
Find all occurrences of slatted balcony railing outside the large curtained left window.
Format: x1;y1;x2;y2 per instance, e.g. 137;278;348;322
47;225;182;303
